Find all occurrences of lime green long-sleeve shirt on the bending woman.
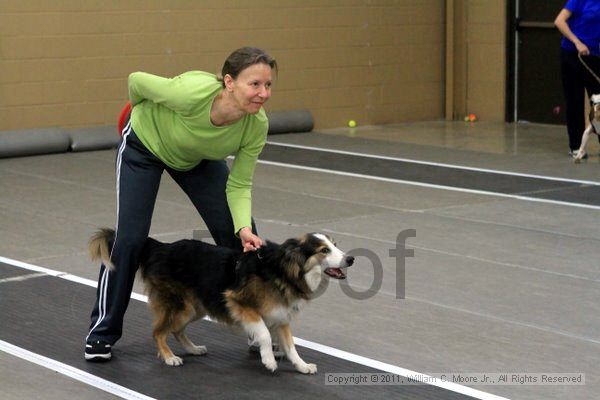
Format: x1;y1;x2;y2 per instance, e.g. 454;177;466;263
128;71;269;232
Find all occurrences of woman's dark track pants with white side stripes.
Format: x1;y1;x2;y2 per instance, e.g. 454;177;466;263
87;125;256;344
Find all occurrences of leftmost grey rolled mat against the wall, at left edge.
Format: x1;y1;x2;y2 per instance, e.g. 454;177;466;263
0;128;71;158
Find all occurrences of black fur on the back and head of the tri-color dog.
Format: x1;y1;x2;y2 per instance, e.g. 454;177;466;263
140;238;316;322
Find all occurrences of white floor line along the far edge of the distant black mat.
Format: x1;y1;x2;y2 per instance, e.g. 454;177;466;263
267;141;600;186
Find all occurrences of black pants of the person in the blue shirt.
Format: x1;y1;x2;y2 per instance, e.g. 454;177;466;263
560;50;600;150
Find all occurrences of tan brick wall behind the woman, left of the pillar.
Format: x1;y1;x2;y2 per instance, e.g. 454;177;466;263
0;0;502;130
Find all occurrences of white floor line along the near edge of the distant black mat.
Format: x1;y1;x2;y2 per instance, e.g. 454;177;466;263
258;159;600;210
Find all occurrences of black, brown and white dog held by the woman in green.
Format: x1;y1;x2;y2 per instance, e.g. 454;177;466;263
90;229;354;374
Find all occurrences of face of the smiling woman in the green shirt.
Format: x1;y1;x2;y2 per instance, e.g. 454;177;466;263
225;63;272;114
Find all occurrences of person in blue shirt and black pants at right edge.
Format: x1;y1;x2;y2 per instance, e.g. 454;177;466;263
554;0;600;157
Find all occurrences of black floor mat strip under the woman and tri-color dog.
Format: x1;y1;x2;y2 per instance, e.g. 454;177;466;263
0;263;470;400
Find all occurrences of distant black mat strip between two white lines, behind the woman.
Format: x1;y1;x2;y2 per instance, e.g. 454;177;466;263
260;144;600;205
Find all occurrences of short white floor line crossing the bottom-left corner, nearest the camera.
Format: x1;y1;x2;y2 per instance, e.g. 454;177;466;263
0;340;154;400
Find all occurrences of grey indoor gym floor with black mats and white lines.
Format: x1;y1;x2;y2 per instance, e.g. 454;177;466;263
0;122;600;399
